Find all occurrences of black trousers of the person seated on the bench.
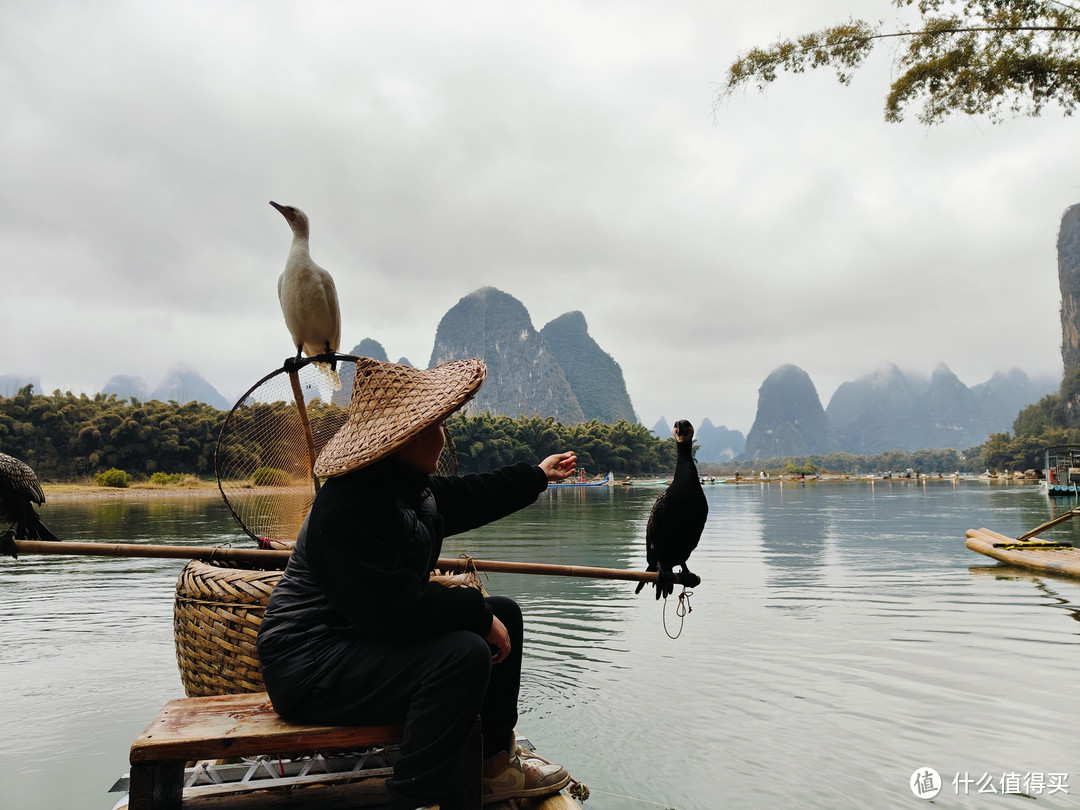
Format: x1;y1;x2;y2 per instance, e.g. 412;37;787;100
289;596;523;810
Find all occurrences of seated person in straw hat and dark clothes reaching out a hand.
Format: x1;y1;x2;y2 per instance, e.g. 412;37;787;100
258;357;577;810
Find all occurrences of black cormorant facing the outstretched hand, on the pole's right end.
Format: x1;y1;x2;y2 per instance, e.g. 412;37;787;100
634;419;708;599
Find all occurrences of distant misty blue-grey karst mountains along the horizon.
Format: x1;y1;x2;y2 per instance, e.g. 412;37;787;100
0;287;1061;462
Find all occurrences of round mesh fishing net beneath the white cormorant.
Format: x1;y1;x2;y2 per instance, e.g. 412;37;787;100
214;353;457;549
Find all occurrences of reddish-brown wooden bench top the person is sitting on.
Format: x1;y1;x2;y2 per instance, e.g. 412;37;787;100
130;692;402;765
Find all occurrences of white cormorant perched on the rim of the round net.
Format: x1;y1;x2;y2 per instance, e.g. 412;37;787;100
270;200;341;391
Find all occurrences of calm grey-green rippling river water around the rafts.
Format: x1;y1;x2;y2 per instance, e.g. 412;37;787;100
0;480;1080;810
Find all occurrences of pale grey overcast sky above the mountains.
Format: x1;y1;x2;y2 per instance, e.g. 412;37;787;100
0;0;1080;433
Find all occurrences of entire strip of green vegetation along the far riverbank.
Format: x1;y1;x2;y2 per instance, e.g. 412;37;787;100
0;386;1019;486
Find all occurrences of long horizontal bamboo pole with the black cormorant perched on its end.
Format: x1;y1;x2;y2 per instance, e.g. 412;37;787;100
8;540;678;582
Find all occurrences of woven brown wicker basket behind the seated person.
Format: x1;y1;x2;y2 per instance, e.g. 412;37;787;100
173;559;483;698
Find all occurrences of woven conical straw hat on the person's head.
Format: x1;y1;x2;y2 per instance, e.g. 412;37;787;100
315;357;487;477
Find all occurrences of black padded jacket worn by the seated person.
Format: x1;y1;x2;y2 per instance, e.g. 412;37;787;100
258;457;548;706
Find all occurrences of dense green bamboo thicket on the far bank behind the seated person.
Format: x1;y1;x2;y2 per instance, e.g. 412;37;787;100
0;386;675;481
